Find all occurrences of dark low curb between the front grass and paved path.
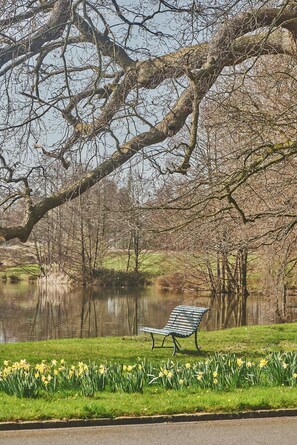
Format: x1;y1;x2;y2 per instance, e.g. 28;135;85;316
0;409;297;431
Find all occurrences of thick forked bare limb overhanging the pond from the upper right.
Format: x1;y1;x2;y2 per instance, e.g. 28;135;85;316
0;0;297;241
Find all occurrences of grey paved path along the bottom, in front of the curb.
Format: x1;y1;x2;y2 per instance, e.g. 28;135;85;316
0;417;297;445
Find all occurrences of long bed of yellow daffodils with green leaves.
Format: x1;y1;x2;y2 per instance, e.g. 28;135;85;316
0;352;297;397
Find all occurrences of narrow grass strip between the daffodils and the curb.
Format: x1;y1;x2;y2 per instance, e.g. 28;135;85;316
0;387;297;421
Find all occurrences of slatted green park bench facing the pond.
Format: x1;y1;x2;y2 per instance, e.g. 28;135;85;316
140;305;209;355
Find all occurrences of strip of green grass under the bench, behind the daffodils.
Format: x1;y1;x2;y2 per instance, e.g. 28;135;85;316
0;323;297;363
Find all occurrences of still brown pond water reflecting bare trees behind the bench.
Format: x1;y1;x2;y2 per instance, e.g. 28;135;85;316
0;282;292;343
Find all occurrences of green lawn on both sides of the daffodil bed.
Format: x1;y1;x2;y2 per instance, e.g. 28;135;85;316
0;323;297;421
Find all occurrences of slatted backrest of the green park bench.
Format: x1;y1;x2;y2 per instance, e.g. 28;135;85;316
165;305;208;335
